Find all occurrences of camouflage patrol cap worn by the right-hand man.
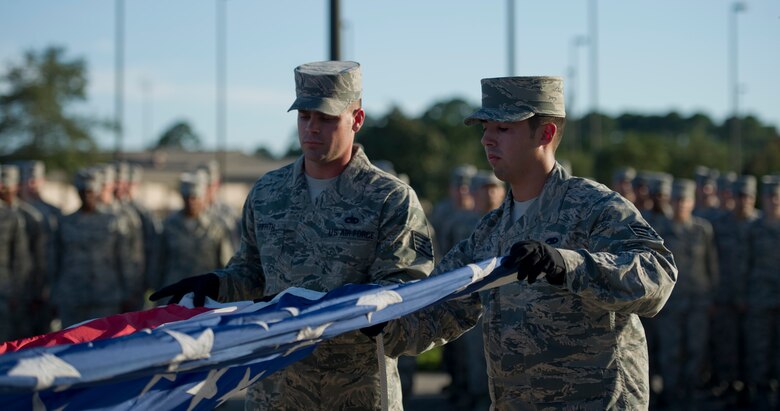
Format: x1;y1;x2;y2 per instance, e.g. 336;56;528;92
463;76;566;126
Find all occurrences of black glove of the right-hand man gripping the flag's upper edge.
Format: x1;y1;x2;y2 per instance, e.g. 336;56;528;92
501;240;566;285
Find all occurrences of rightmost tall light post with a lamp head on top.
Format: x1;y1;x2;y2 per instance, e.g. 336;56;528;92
729;1;746;173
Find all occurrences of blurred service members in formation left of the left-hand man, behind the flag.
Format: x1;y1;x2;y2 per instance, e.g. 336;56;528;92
0;161;239;341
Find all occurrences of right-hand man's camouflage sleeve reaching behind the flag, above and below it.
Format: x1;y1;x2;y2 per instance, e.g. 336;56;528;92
385;222;482;357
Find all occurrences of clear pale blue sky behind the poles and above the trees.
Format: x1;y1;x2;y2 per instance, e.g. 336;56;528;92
0;0;780;158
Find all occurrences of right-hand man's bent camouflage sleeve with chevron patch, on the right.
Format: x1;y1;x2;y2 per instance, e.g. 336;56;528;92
558;196;677;317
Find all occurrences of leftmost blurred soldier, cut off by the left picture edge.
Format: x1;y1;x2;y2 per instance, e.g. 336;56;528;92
0;166;32;341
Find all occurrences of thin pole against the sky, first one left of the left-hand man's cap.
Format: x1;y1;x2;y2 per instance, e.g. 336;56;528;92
216;0;227;178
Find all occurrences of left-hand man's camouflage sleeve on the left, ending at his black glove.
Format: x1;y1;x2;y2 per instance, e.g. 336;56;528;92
215;190;265;302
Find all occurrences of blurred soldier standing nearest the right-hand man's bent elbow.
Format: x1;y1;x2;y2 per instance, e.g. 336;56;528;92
655;179;718;409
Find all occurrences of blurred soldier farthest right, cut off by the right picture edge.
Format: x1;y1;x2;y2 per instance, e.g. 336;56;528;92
745;176;780;410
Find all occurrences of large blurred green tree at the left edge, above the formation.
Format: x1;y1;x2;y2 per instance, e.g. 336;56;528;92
0;47;109;171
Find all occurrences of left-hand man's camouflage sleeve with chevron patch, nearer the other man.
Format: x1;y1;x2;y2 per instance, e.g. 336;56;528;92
369;187;433;284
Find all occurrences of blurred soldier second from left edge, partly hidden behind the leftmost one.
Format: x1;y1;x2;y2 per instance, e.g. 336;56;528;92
19;160;62;335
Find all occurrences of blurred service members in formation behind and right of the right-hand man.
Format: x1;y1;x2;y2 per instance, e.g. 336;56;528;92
426;165;780;409
